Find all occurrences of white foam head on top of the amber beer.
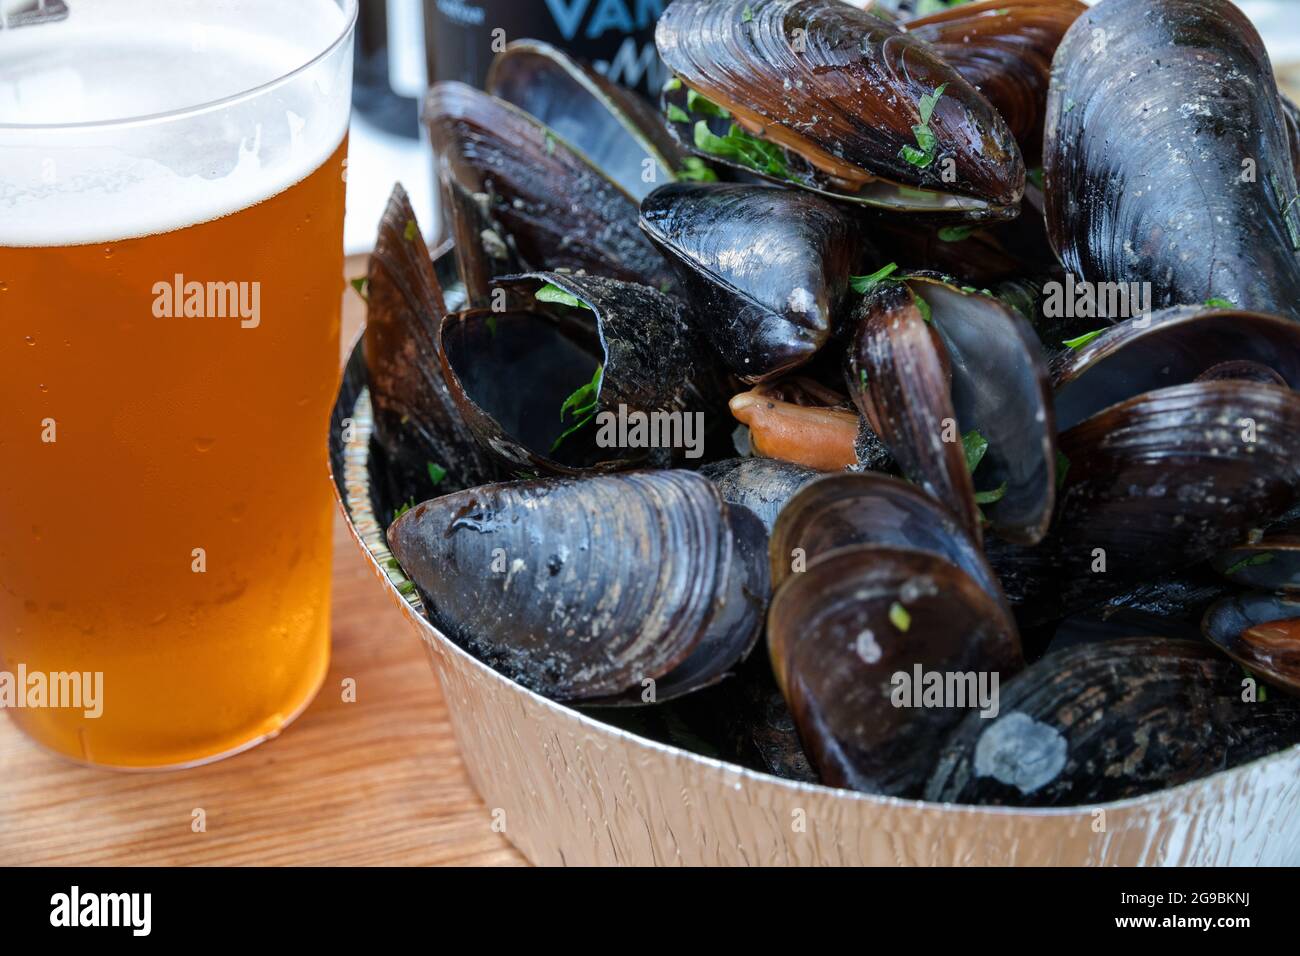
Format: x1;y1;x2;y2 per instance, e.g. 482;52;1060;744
0;0;352;246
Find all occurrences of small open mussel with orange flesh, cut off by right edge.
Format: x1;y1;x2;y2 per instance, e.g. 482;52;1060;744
1201;592;1300;693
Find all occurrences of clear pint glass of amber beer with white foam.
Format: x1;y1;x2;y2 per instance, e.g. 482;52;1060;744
0;0;356;767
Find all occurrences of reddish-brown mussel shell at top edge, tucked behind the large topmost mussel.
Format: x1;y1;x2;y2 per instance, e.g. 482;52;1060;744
906;0;1088;165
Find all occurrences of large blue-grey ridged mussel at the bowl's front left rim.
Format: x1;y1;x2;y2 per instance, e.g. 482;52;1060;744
389;471;768;704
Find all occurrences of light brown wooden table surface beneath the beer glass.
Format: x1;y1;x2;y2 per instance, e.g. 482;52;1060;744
0;258;524;865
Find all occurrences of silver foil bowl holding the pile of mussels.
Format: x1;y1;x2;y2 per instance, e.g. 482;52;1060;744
330;341;1300;865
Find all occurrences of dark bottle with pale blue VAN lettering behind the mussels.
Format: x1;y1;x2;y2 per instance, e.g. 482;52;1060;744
424;0;668;99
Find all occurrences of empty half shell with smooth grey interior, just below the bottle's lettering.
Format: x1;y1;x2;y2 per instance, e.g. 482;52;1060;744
486;40;685;202
